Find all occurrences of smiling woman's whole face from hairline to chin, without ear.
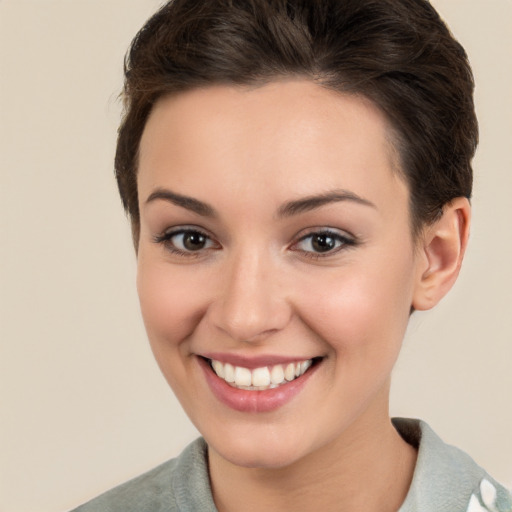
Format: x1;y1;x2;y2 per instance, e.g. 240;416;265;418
138;81;421;467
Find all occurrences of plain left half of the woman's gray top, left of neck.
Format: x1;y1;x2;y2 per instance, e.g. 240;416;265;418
68;439;215;512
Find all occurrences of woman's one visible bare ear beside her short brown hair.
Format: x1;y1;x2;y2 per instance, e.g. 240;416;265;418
412;197;471;310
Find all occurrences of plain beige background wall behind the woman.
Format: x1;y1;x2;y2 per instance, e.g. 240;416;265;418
0;0;512;512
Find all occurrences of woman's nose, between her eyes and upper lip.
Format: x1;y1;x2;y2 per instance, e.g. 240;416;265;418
208;251;292;343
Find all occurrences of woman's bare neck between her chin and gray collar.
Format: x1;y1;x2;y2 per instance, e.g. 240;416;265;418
209;388;416;512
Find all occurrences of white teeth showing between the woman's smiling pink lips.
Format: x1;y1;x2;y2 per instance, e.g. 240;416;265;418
206;357;322;391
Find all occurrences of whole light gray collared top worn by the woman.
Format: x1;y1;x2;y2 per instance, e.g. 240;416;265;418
73;418;512;512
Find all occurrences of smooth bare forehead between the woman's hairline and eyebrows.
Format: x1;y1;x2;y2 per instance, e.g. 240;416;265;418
138;80;405;214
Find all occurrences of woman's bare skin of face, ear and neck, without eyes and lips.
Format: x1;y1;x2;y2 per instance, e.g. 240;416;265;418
137;80;469;512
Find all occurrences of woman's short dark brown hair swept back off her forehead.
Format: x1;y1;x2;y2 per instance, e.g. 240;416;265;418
115;0;478;246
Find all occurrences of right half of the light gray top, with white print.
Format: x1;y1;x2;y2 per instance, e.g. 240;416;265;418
393;418;512;512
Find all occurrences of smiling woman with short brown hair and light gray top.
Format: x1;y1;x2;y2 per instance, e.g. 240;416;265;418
71;0;512;512
